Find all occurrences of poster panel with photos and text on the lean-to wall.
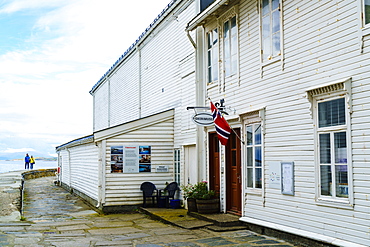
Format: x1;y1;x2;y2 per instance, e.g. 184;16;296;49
110;145;152;173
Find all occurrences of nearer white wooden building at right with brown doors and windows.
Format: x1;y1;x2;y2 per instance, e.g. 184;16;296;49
186;0;370;246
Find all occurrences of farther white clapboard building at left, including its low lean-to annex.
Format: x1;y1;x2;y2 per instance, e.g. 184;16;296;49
57;0;198;212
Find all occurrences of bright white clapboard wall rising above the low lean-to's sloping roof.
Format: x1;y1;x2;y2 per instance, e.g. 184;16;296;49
93;1;195;151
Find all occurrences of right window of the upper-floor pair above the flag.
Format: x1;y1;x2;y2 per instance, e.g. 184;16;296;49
223;16;238;76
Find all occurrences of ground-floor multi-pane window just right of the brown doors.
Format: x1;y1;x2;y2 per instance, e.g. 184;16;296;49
246;123;262;188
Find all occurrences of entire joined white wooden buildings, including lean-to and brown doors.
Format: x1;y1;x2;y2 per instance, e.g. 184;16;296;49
57;0;370;247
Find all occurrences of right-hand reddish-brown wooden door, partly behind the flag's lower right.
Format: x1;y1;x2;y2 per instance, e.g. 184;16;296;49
225;129;242;215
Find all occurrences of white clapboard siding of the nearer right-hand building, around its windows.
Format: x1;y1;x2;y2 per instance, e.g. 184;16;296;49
198;0;370;245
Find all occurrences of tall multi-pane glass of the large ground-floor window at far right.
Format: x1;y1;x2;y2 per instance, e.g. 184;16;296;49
317;98;349;198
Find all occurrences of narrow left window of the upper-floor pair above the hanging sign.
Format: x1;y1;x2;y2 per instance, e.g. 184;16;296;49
207;28;218;83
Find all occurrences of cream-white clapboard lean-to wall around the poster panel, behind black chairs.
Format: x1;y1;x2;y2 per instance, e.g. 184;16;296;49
105;117;174;206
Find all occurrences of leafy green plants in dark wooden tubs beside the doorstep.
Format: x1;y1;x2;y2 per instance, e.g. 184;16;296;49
182;181;220;214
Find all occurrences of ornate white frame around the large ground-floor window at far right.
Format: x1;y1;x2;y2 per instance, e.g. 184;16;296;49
306;78;354;209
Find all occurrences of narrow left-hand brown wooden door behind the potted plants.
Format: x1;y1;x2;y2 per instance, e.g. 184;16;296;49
209;132;220;195
